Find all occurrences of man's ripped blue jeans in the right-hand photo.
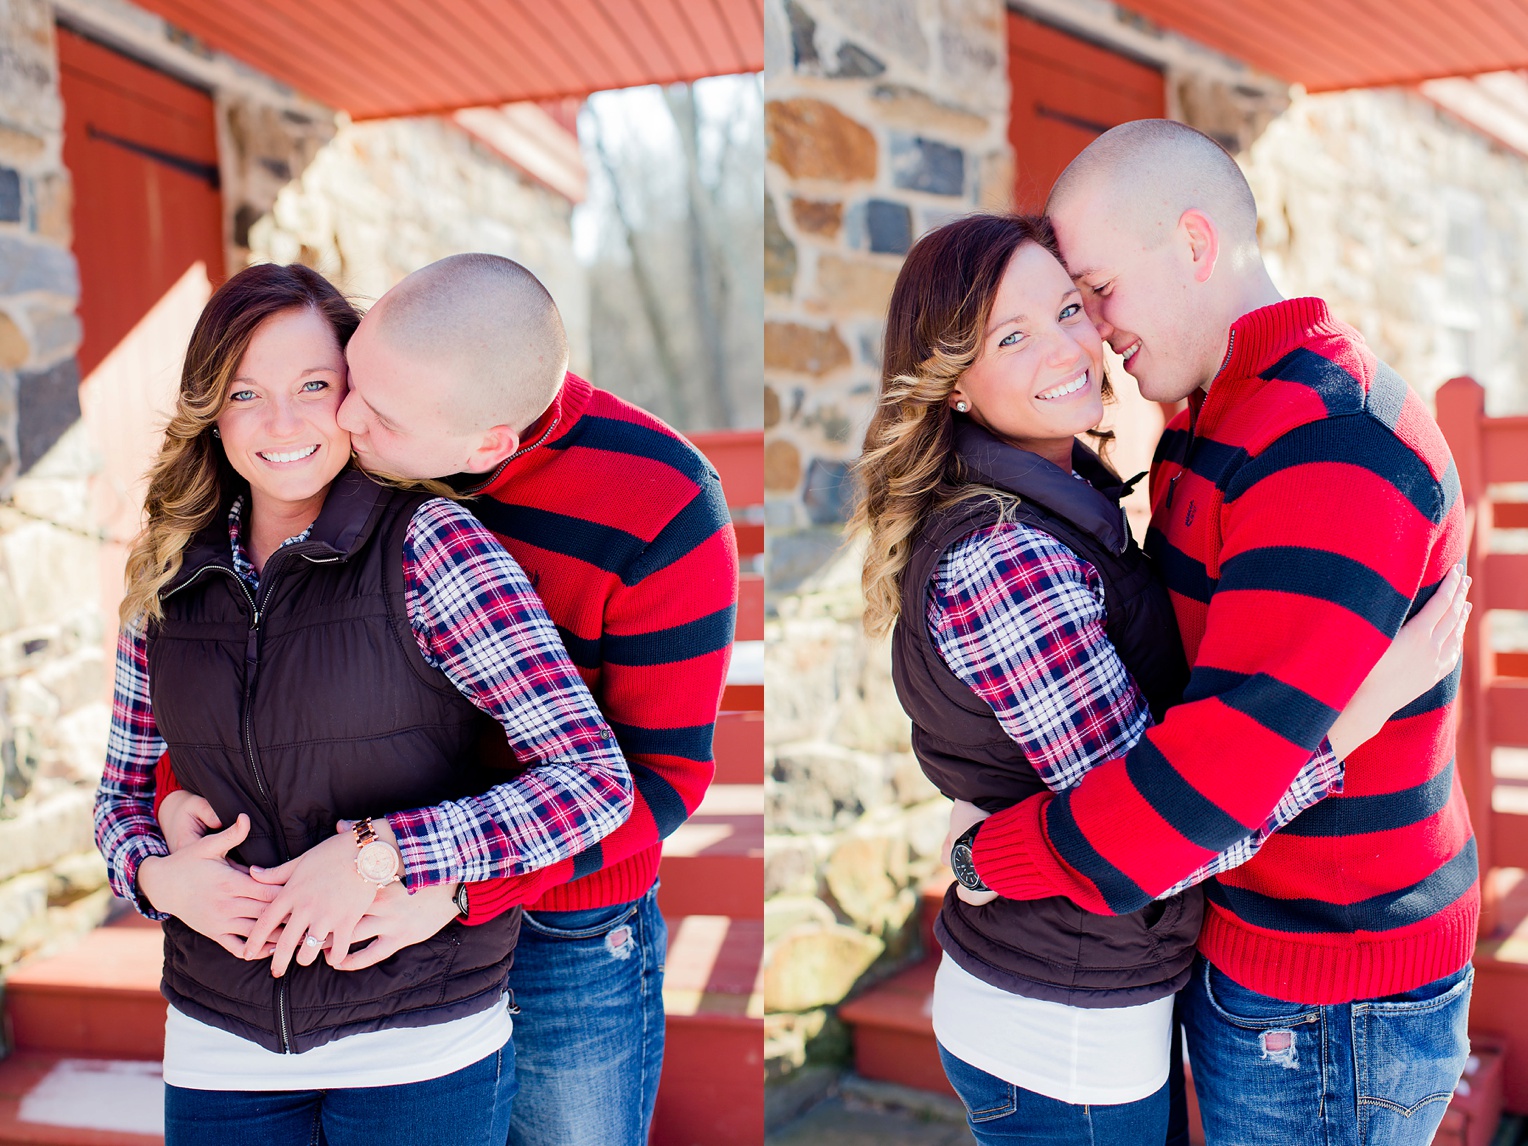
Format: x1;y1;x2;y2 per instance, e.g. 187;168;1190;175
1183;957;1475;1146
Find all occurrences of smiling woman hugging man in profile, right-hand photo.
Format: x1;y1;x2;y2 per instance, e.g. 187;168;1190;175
856;215;1467;1146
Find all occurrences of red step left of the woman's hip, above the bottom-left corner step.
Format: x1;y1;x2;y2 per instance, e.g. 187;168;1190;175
5;926;165;1060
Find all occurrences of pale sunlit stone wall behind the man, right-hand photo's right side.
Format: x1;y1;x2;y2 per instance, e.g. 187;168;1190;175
1239;89;1528;416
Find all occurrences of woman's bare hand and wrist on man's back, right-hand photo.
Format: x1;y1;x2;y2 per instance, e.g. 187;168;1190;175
1326;565;1471;759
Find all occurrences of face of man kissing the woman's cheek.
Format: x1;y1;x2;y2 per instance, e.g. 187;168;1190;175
338;310;487;478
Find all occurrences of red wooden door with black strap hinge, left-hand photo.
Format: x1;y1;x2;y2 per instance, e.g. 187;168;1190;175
58;29;223;691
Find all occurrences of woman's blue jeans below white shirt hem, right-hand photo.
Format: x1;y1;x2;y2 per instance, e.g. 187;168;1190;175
940;1047;1169;1146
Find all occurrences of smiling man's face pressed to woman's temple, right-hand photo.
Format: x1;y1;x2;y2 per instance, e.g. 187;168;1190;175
1051;194;1225;402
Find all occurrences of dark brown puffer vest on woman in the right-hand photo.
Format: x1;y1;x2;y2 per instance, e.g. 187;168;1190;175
891;419;1204;1007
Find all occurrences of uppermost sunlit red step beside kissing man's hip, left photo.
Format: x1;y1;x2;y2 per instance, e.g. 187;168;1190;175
659;784;764;920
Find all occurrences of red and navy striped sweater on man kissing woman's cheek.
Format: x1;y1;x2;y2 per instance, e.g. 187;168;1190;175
468;374;738;923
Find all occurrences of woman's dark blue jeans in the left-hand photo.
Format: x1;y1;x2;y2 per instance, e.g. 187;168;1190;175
165;1042;515;1146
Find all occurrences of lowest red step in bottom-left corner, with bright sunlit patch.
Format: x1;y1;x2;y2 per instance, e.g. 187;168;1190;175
0;1051;165;1146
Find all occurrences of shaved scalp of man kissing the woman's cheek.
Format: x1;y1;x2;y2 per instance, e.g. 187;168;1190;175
367;254;568;431
